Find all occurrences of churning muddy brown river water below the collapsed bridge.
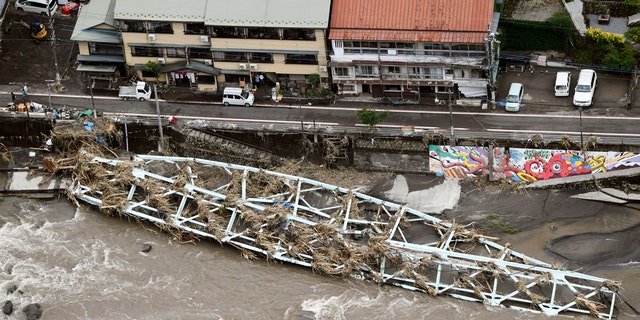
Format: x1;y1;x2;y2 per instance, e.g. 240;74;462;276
0;198;640;320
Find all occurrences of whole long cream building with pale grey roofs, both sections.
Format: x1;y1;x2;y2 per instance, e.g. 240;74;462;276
74;0;331;90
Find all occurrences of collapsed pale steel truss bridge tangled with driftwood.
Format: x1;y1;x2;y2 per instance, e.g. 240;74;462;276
69;155;619;319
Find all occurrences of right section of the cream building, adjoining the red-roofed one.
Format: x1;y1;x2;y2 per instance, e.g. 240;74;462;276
204;0;331;89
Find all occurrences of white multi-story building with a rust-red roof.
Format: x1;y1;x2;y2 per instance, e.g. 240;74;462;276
329;0;497;99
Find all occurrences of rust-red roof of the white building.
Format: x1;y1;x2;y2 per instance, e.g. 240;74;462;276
329;0;494;43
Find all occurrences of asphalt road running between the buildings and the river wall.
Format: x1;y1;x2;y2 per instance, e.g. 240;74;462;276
8;92;640;146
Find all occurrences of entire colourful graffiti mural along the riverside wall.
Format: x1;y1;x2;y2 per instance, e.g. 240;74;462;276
429;145;640;182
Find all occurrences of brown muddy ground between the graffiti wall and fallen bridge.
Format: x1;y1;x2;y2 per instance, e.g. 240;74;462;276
370;175;640;319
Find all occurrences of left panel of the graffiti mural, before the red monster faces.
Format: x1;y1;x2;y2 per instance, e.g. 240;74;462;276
429;145;489;178
